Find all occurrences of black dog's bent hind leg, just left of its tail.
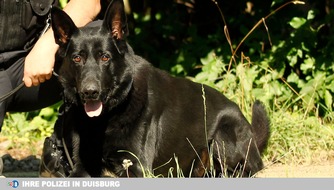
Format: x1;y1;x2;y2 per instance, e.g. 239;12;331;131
213;105;263;177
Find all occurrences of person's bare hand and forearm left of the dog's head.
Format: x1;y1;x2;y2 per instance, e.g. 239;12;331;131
23;31;58;87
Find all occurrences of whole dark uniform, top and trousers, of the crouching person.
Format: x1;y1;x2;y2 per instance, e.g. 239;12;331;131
0;0;61;130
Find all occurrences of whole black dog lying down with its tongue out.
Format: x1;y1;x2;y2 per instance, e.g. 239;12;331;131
52;0;269;177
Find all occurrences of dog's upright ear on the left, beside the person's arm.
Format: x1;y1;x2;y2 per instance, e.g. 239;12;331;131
51;7;78;47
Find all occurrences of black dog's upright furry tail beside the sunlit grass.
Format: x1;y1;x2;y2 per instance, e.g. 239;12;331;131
252;100;270;153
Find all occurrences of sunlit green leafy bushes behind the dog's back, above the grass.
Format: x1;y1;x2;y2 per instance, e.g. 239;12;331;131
187;1;334;121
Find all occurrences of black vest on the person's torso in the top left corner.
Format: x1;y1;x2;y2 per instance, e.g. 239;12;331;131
0;0;59;53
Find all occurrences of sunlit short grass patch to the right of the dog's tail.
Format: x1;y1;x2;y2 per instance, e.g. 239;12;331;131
265;106;334;164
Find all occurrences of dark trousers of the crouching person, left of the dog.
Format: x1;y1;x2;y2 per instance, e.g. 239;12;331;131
0;51;62;130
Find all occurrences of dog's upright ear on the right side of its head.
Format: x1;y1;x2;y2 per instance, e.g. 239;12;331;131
103;0;128;41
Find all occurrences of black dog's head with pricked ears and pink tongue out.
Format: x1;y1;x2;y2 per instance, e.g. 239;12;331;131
51;0;132;117
